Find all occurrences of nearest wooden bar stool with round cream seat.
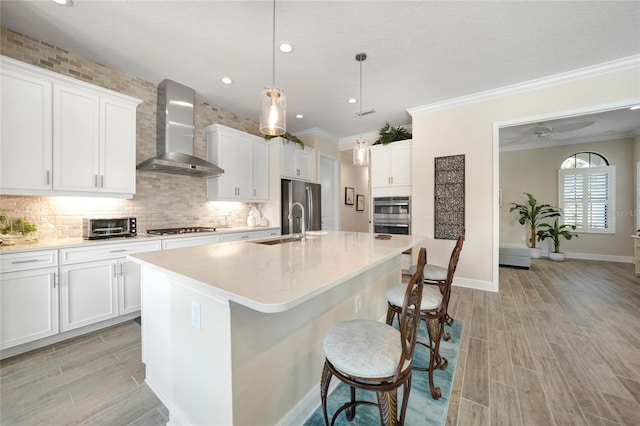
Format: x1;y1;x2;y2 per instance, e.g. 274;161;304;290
320;248;427;426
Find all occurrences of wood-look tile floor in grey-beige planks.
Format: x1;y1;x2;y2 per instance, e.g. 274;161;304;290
0;259;640;426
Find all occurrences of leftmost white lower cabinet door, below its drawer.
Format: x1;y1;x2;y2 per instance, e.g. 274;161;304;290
0;267;58;349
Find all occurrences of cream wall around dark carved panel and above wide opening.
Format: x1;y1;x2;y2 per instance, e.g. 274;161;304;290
409;58;640;291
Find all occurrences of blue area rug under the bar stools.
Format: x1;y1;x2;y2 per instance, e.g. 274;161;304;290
305;320;464;426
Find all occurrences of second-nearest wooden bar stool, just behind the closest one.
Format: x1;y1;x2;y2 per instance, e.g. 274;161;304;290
385;232;464;399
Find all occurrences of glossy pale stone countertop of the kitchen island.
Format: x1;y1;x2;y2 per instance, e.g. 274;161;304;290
128;231;426;313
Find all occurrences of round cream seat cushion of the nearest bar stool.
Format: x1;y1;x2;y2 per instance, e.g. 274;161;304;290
323;320;410;379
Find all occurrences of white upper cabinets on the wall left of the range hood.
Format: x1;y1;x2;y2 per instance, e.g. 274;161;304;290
0;57;140;197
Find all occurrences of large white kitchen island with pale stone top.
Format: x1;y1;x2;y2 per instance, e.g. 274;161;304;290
129;231;425;425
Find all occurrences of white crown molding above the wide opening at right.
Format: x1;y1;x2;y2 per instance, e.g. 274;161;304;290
407;55;640;117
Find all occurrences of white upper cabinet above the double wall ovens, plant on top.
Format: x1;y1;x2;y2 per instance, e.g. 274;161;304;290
369;140;411;191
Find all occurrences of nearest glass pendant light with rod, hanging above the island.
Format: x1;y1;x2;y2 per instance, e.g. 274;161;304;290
260;0;287;136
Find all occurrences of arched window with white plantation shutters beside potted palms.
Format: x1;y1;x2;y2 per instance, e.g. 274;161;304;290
558;152;616;233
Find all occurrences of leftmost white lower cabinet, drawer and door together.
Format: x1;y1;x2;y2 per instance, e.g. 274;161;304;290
0;250;58;349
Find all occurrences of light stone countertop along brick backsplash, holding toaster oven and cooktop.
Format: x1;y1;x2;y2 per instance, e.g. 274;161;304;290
0;226;280;254
